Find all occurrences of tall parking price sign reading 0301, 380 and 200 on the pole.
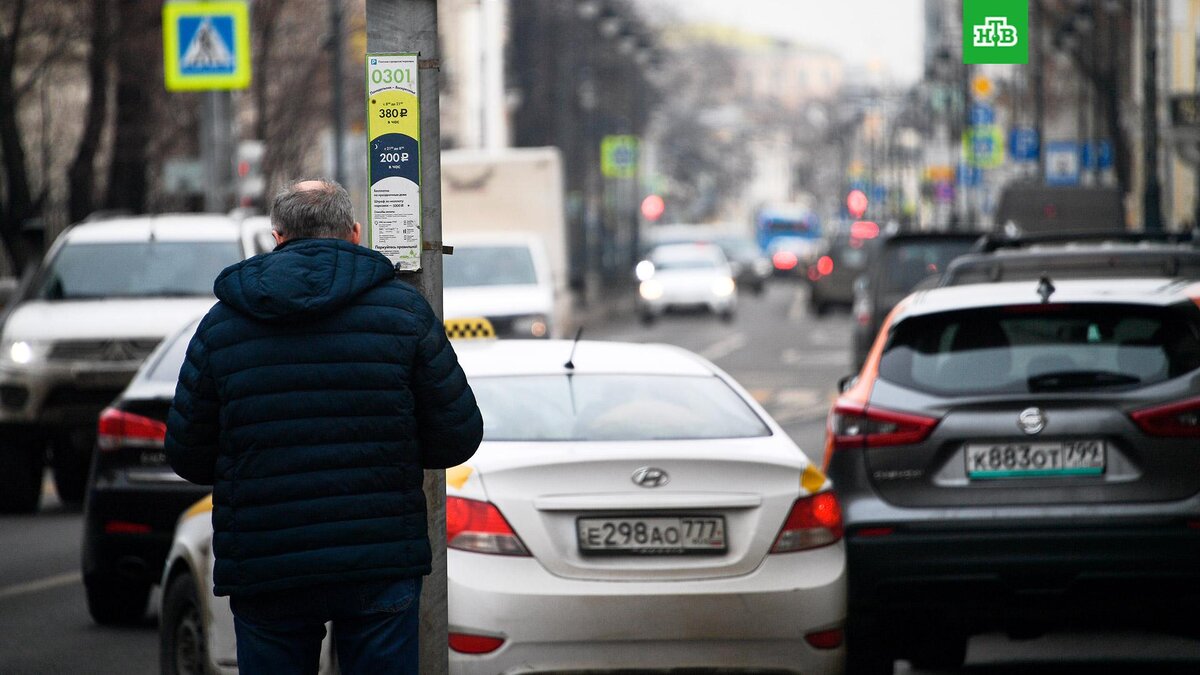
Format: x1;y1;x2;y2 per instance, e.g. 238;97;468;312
367;54;421;271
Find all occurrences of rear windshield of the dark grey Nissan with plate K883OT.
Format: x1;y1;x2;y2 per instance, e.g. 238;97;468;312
880;304;1200;395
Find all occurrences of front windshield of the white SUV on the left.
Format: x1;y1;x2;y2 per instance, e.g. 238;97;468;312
34;241;241;300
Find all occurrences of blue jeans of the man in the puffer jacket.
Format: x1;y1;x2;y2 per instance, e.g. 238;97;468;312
229;578;421;675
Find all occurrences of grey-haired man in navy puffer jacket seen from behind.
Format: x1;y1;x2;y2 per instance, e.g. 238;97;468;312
166;180;482;675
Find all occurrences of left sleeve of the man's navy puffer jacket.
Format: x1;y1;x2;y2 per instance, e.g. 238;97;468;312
164;321;221;485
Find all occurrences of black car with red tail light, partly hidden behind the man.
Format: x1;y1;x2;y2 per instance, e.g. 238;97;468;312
82;323;211;625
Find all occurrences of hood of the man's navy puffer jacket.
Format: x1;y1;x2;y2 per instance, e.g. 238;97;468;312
214;239;395;321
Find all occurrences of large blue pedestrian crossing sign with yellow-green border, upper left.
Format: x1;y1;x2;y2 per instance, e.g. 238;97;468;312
162;0;250;91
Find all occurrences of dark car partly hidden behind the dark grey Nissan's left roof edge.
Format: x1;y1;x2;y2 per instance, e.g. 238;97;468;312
851;232;980;369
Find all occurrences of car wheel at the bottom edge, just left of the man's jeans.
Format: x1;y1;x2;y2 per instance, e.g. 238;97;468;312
158;574;209;675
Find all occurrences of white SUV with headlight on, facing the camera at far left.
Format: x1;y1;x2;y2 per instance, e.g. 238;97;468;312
0;214;274;512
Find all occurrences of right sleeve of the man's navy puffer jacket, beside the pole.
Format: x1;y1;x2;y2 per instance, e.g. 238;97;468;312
413;303;484;468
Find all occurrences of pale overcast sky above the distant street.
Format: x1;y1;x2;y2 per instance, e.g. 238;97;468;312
658;0;924;84
